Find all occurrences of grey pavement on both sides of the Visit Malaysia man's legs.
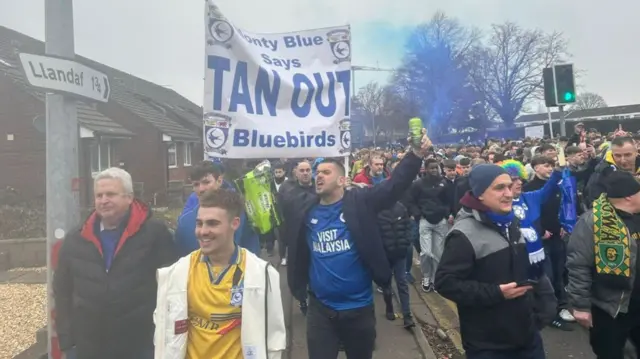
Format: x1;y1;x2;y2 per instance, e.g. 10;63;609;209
263;252;436;359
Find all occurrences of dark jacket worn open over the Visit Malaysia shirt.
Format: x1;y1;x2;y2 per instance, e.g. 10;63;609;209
284;152;422;299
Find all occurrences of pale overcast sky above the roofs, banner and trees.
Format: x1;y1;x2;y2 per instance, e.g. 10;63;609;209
0;0;640;112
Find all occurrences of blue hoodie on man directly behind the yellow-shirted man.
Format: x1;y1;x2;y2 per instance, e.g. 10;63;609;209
174;189;260;256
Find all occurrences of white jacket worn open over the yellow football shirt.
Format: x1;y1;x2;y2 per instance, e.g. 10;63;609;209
153;249;287;359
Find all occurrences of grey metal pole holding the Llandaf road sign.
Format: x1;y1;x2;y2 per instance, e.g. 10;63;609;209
45;0;80;359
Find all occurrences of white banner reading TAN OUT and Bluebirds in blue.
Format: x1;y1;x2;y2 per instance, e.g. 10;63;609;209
203;0;351;158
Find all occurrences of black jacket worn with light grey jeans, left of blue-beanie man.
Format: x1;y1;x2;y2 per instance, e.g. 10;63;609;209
405;175;451;224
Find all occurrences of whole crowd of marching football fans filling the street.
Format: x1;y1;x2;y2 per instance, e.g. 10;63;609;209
54;124;640;359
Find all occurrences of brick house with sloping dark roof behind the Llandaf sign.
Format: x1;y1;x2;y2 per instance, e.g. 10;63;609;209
0;26;203;205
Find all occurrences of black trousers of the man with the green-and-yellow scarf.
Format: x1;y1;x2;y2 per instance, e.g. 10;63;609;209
589;303;640;359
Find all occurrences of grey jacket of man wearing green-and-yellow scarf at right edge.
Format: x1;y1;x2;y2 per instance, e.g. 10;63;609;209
567;210;637;318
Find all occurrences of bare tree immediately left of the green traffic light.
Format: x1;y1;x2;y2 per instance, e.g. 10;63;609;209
469;22;568;126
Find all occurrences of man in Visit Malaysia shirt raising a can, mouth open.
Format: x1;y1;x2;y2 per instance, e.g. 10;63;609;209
285;131;431;359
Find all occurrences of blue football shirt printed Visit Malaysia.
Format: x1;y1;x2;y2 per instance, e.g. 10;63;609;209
306;201;373;310
